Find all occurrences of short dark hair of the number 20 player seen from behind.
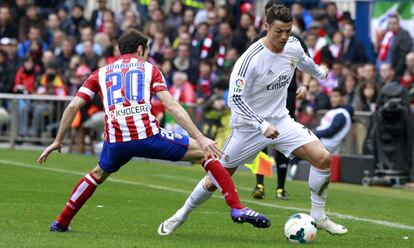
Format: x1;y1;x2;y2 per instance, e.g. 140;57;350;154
118;28;148;54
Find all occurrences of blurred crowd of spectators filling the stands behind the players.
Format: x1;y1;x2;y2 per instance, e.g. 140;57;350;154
0;0;414;140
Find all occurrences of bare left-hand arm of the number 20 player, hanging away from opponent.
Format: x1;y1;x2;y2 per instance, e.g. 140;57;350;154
37;96;86;164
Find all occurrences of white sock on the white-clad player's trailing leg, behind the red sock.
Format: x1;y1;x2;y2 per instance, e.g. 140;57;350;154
175;176;214;220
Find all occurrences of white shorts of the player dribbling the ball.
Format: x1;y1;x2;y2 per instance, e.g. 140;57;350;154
220;115;319;168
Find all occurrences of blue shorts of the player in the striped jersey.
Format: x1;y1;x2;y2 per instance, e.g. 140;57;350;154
98;128;190;173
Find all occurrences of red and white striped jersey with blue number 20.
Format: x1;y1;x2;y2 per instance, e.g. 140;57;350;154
76;54;167;143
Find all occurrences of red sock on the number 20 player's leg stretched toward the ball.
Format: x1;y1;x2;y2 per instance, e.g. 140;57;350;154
203;158;244;209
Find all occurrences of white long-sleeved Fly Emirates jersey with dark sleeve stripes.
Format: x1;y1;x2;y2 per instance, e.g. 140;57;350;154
228;36;326;133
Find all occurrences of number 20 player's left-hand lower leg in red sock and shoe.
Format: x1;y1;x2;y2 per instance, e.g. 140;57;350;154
50;167;107;232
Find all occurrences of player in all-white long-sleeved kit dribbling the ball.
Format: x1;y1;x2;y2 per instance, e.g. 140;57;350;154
161;5;347;234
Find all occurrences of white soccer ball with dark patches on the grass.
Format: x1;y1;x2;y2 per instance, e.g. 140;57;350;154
285;213;318;244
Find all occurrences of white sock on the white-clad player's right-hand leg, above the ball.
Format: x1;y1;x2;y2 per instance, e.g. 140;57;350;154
308;166;331;220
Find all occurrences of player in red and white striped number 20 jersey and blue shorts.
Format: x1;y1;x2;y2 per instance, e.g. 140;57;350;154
38;29;270;234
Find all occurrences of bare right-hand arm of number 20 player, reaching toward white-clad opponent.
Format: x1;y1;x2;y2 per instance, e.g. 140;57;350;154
156;90;223;159
